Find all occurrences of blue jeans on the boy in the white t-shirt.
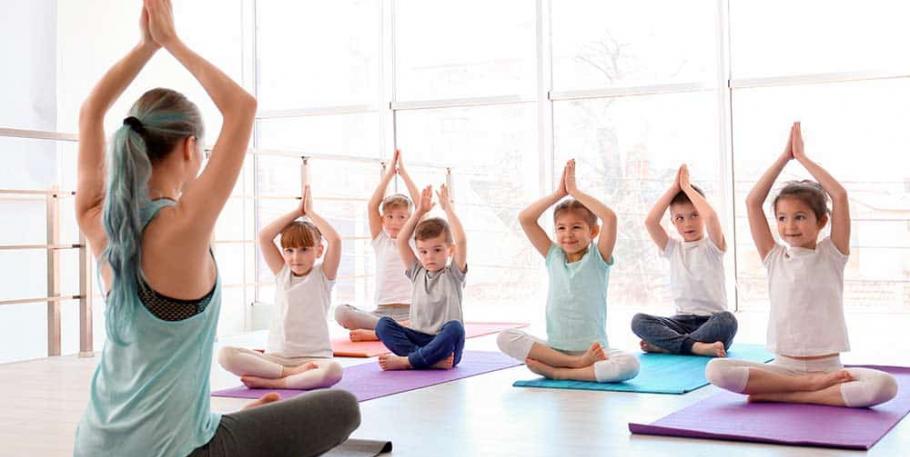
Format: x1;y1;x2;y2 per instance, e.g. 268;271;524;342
632;311;738;354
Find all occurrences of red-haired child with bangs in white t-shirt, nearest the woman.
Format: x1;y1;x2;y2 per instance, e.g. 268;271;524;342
218;186;342;389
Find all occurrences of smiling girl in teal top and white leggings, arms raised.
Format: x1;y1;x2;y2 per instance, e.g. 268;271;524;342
496;160;639;382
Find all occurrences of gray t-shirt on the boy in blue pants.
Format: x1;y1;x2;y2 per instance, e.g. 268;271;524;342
405;261;468;335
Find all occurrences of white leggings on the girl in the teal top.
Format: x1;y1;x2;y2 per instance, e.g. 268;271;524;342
496;329;638;382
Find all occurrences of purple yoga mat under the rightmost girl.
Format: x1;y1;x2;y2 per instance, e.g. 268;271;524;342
629;365;910;449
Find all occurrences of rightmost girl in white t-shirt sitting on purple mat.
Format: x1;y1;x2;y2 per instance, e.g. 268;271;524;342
705;122;897;407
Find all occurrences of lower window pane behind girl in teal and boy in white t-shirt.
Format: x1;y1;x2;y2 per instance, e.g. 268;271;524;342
553;91;721;307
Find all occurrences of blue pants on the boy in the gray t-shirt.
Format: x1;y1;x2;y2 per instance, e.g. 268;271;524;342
375;317;464;369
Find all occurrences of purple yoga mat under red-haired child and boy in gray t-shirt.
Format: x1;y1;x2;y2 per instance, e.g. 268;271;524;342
212;351;522;401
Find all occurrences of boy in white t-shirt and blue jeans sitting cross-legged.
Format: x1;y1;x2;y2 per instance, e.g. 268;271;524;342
632;164;737;357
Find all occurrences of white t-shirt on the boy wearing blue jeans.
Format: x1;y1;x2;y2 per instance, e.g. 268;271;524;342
660;236;727;316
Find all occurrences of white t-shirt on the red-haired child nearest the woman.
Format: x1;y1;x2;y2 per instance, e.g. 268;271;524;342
266;263;335;358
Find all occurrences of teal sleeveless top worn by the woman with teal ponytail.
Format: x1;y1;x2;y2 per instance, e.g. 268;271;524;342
74;200;221;457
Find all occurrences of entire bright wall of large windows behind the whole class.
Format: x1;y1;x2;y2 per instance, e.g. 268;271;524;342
0;0;910;359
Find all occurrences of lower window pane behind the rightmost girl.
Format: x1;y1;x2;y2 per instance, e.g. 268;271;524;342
733;79;910;311
